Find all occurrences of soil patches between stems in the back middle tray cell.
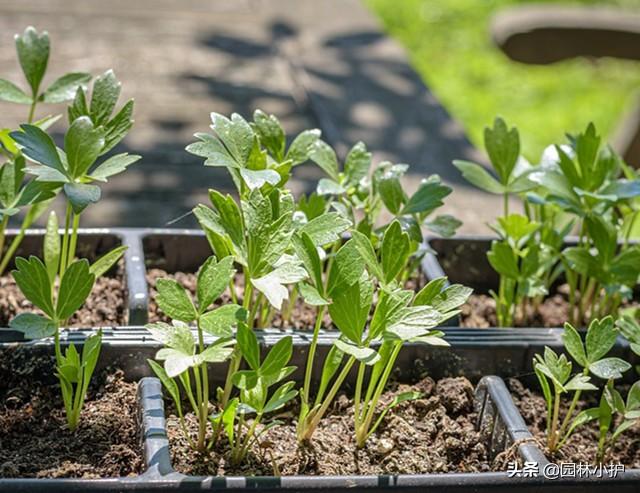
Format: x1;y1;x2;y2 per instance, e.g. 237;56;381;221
147;269;422;330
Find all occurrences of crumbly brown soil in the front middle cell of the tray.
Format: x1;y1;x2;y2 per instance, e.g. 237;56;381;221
167;377;502;475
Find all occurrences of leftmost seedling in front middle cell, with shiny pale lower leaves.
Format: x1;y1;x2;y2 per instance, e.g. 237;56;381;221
146;257;246;452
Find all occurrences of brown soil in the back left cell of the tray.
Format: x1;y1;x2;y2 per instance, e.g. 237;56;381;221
0;261;127;328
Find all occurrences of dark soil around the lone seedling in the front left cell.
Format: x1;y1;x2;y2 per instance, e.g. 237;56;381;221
0;348;143;478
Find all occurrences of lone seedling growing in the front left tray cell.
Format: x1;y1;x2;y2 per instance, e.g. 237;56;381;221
9;212;126;431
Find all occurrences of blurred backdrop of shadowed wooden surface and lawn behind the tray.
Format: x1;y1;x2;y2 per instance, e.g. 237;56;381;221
0;0;640;233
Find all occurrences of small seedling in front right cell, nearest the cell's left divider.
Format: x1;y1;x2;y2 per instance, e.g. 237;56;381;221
533;317;631;453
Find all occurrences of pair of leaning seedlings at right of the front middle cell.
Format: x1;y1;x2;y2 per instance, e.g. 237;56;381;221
298;229;470;447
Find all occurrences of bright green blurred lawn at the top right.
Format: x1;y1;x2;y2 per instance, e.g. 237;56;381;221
366;0;640;161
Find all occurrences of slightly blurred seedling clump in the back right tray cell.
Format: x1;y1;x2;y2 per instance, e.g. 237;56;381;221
454;118;640;327
